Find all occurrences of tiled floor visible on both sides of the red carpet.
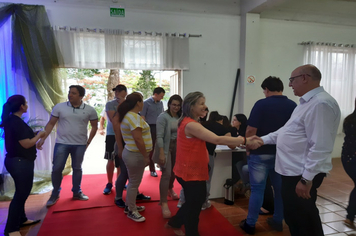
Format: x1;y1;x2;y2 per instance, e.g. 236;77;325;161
0;158;356;236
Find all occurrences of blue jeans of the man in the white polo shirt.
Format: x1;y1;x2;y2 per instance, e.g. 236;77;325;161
52;143;86;196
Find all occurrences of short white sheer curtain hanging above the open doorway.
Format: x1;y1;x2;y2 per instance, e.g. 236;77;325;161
55;27;189;70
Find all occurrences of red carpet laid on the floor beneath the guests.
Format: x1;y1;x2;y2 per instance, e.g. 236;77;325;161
37;173;242;236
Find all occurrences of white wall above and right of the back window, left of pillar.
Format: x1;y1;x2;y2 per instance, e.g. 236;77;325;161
46;4;240;115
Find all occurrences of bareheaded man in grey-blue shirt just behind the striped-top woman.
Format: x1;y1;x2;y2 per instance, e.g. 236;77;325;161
140;87;166;177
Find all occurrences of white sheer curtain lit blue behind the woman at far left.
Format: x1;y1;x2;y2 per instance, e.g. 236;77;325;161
0;16;55;196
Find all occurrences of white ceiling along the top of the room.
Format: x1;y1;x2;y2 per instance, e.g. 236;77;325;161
0;0;356;26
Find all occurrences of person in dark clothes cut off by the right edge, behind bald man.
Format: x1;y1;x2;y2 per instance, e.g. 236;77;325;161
341;99;356;229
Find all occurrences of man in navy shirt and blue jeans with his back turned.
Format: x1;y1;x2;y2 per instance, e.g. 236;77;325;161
240;76;297;234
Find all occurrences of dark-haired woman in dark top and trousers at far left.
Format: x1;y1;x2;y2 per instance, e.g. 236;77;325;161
0;95;46;236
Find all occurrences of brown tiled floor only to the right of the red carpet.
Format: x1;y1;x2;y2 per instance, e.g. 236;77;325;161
213;158;356;236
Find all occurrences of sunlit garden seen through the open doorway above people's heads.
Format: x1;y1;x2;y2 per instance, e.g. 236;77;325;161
60;68;182;110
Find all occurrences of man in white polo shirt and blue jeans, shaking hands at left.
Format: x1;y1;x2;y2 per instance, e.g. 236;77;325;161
37;85;98;207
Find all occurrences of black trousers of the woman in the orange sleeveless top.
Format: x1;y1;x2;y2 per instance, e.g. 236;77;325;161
168;177;206;236
